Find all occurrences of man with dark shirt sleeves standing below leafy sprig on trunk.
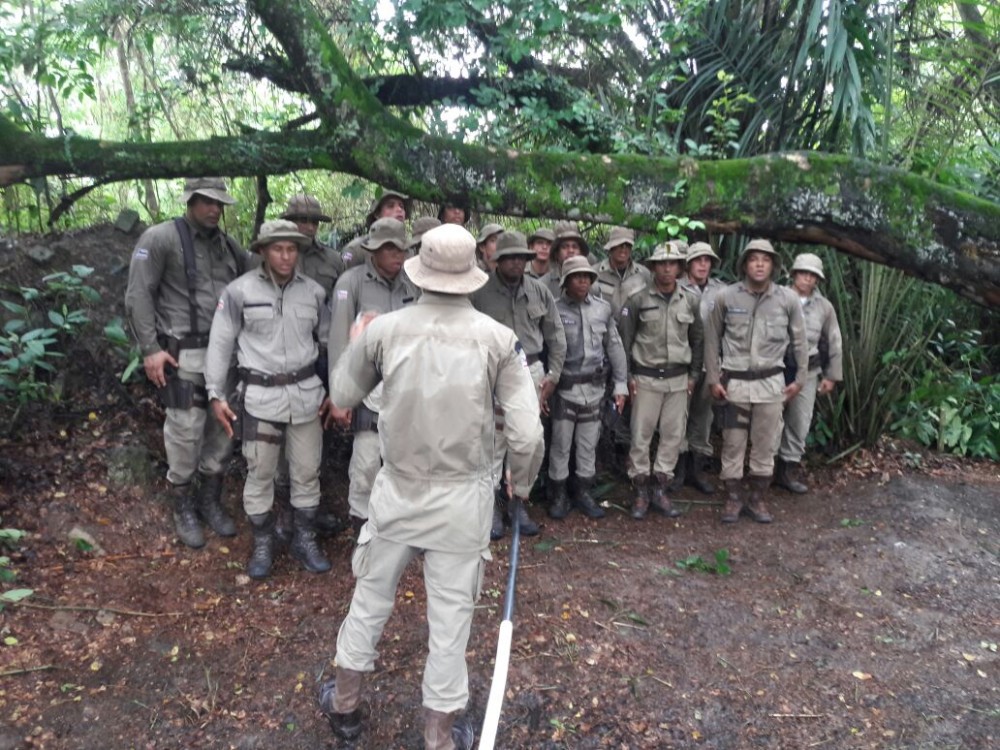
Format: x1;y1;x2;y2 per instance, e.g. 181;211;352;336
620;242;704;519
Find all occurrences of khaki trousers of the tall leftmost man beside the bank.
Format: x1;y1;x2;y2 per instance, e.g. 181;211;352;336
163;358;233;484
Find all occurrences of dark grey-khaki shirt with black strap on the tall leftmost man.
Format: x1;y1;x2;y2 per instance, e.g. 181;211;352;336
125;218;249;357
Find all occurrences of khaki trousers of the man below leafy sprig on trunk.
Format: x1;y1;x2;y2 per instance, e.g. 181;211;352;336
628;375;688;479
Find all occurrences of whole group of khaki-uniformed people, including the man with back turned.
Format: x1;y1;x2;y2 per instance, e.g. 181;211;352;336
126;178;841;750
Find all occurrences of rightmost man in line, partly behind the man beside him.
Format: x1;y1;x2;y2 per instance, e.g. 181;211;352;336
774;253;844;495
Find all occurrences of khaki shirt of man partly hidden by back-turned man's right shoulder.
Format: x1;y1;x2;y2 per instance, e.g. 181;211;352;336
470;272;566;383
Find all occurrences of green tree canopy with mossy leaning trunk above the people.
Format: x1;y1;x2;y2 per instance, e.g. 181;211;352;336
0;0;1000;306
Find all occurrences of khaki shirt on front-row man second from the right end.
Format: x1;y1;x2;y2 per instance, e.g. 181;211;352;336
705;281;809;403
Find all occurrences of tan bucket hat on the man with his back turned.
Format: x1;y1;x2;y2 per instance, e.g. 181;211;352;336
403;224;490;294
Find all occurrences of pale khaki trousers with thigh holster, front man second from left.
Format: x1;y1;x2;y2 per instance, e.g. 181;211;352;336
243;415;323;516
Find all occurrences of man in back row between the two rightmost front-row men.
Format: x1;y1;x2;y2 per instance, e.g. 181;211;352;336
671;242;726;495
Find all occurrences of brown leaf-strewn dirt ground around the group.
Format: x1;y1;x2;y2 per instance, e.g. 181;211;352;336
0;227;1000;750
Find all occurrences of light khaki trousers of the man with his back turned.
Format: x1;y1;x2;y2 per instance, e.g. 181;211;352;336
336;528;489;713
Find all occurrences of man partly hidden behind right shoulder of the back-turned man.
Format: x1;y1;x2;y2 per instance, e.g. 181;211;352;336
471;231;566;539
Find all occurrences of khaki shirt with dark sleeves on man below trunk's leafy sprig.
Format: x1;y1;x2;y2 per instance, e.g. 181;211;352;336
619;284;705;390
